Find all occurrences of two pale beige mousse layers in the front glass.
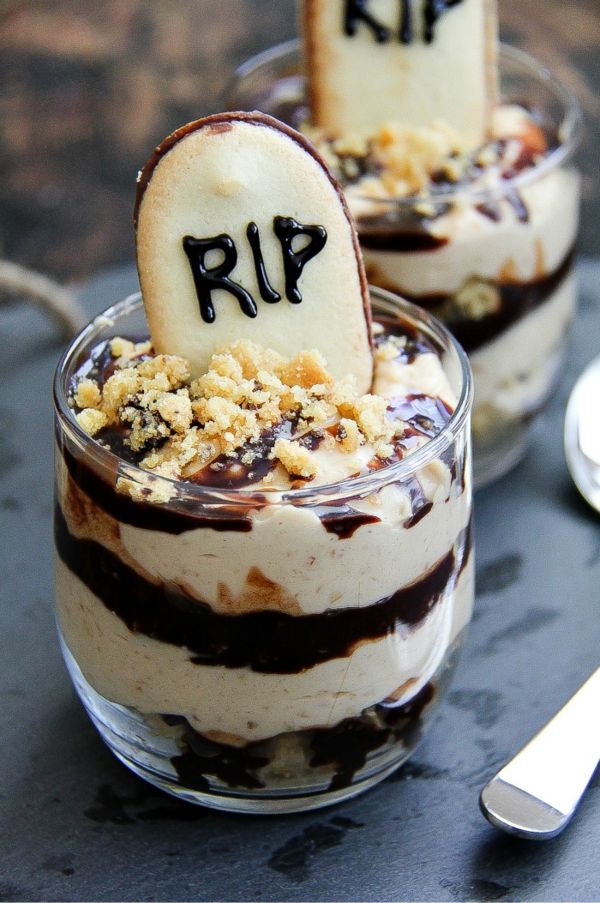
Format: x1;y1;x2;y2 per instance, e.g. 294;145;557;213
57;426;473;742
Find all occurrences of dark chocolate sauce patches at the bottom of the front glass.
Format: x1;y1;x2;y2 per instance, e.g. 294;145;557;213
169;683;435;792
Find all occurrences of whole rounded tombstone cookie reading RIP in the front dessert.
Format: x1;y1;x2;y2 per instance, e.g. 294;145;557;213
135;113;372;391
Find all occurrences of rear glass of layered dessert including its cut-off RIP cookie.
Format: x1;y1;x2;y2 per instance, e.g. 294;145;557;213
228;0;579;485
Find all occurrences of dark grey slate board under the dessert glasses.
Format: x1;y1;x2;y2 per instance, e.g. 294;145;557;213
0;261;600;900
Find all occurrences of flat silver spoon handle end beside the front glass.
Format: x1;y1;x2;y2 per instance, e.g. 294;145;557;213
479;668;600;840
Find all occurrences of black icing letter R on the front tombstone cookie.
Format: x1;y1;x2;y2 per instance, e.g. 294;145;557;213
183;234;258;323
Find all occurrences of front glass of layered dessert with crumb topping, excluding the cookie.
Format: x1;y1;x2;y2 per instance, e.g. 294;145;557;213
55;109;473;811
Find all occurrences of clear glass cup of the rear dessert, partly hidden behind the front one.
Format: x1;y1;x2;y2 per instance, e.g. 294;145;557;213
224;41;581;488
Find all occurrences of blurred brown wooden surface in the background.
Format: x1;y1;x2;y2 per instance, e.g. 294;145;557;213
0;0;600;281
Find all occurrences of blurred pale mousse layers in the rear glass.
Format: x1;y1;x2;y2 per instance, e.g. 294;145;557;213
349;169;579;442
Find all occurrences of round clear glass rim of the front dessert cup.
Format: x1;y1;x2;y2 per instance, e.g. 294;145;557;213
53;286;473;507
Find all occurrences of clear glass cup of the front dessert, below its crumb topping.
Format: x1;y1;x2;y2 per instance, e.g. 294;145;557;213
54;289;473;813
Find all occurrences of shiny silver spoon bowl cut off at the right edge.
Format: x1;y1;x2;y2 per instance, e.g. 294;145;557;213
564;357;600;511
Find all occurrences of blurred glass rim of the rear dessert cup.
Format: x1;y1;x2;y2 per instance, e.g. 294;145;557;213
223;38;583;208
